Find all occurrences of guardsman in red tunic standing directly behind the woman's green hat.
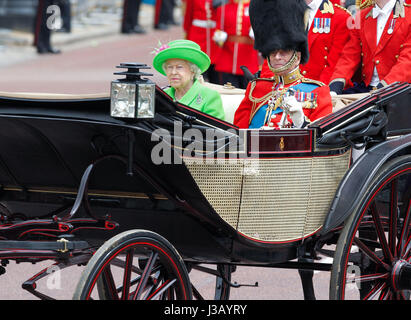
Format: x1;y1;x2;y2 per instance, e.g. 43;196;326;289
183;0;219;83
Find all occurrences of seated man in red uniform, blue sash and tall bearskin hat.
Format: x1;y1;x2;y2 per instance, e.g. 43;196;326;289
234;0;332;128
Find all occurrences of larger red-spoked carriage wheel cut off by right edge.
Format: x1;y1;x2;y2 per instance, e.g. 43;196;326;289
330;155;411;300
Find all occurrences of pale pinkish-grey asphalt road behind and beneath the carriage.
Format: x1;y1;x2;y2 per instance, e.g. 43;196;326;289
0;27;329;300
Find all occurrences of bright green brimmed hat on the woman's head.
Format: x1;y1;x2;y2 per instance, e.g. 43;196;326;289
153;40;210;75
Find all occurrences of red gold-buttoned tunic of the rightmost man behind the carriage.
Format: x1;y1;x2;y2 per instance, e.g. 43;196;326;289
332;2;411;86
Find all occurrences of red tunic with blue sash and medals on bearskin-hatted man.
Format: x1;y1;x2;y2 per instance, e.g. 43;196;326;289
234;67;332;129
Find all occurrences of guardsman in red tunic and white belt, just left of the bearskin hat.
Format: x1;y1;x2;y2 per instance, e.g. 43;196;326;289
213;0;259;89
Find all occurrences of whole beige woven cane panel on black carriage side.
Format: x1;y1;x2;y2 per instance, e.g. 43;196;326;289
185;152;350;242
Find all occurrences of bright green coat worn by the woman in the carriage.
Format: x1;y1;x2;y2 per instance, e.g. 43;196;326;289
164;81;225;120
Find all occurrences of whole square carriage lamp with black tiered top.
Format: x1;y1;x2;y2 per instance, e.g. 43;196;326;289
110;63;155;119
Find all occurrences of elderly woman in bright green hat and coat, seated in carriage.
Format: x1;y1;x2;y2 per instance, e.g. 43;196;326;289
153;40;225;120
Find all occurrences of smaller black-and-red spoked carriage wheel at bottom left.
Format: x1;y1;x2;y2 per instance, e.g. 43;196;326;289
73;230;192;300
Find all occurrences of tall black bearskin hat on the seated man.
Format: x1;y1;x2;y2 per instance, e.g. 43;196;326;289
249;0;309;64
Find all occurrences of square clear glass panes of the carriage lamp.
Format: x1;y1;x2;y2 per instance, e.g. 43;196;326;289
110;81;155;119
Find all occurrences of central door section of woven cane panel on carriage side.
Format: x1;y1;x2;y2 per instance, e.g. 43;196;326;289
238;158;311;241
